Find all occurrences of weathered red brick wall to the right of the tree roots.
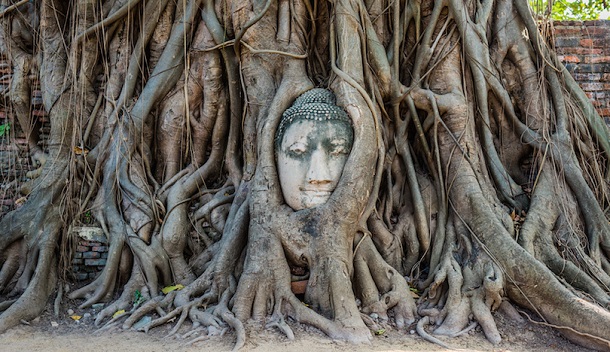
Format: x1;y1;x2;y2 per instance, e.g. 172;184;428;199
554;20;610;119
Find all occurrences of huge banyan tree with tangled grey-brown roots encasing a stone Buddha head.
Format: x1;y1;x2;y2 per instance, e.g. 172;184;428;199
0;0;610;350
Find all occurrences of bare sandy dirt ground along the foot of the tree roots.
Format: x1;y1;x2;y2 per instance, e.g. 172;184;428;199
0;300;591;352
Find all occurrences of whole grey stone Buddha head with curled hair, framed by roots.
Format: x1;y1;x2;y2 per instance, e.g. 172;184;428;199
275;88;354;210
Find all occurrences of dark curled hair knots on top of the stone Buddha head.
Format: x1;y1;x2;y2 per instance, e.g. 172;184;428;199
275;88;352;150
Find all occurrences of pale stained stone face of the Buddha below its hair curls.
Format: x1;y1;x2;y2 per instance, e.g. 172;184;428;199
277;119;353;210
